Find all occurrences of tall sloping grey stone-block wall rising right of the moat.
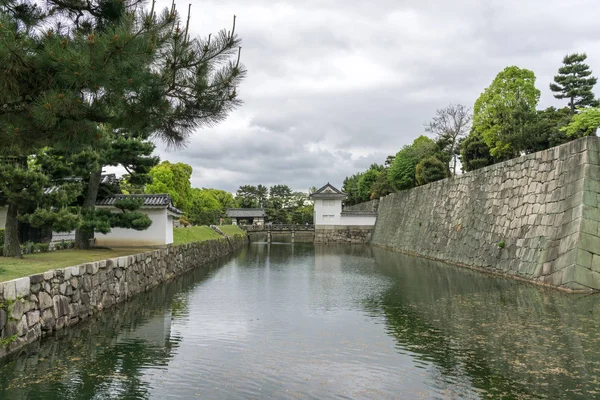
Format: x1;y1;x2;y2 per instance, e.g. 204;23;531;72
372;137;600;290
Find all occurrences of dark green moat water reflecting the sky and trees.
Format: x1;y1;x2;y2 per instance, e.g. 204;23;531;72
0;244;600;400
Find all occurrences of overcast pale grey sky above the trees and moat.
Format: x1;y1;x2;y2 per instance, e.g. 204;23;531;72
124;0;600;192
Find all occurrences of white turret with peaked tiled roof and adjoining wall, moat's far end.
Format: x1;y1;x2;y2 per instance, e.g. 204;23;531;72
309;183;377;229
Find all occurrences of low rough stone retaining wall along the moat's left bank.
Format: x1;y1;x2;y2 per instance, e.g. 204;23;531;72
0;236;247;357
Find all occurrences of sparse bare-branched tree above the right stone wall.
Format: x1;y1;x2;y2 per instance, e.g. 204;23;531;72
425;104;472;175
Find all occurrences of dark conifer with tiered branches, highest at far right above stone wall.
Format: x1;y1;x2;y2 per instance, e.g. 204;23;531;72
550;53;599;115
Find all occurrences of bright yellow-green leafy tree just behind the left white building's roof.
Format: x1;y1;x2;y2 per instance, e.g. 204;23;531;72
145;161;192;212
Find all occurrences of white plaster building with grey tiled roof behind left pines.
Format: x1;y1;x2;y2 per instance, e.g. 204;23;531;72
95;194;183;247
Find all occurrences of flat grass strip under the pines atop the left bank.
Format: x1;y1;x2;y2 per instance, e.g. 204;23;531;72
0;247;151;282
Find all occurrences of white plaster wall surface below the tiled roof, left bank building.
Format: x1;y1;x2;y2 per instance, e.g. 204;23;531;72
95;208;173;247
